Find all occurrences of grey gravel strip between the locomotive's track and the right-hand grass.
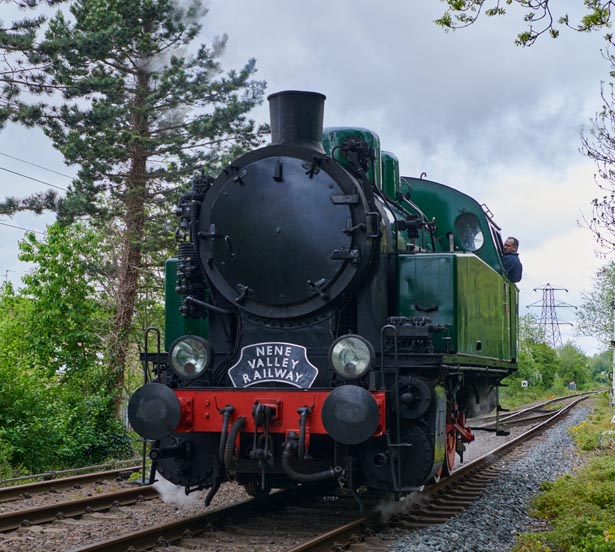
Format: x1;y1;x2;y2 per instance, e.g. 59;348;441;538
390;407;589;552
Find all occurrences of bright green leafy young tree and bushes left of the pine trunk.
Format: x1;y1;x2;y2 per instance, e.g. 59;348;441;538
0;224;130;477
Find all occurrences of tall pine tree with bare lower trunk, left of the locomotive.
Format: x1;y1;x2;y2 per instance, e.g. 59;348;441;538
0;0;266;405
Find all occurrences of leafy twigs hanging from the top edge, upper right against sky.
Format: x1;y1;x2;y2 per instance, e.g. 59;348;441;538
435;0;614;46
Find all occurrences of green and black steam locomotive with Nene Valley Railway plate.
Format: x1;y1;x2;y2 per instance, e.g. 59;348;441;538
128;91;518;504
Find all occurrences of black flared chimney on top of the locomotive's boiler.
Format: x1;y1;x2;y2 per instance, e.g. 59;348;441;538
267;90;326;153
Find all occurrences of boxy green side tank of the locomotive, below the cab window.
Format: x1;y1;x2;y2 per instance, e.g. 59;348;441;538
398;253;518;361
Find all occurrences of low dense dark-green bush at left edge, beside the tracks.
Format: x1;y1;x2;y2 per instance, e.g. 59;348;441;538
0;366;131;477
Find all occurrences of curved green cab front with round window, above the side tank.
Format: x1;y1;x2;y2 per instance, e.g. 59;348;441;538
401;176;504;274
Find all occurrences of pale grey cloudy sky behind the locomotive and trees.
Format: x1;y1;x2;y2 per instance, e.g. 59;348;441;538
0;0;609;353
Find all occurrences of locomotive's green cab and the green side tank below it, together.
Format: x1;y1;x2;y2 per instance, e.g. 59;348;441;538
397;177;519;365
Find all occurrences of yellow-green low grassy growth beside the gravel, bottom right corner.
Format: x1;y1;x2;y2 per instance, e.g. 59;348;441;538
512;394;615;552
